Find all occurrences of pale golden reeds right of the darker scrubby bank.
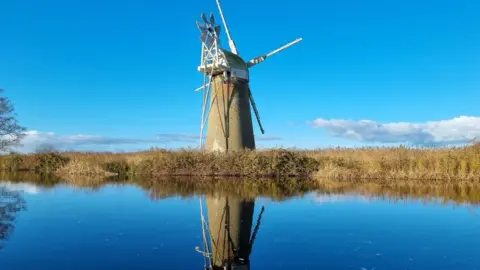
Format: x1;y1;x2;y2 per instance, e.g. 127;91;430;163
306;143;480;183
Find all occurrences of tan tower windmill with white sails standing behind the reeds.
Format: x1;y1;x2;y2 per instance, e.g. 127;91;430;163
195;0;302;152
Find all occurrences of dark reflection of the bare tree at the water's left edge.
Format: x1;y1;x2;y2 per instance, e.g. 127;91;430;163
0;185;26;249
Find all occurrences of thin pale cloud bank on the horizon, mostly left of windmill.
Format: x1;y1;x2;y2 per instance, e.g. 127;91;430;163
10;130;281;153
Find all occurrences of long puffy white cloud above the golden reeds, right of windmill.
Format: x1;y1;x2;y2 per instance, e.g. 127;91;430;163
308;116;480;145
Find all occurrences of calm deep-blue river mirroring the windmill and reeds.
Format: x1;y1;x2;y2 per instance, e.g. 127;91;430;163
0;176;480;270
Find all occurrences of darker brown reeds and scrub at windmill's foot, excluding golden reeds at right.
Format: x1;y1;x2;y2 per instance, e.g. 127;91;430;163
0;150;318;177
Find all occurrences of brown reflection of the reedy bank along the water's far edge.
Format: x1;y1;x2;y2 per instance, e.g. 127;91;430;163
1;173;480;205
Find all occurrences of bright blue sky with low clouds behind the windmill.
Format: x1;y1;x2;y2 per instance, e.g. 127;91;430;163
0;0;480;152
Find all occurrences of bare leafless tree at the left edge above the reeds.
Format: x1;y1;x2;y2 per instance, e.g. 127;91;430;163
0;89;26;152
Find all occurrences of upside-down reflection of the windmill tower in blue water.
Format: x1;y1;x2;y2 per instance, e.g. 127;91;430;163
200;196;265;270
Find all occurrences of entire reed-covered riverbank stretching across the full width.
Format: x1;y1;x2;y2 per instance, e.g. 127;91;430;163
0;143;480;183
